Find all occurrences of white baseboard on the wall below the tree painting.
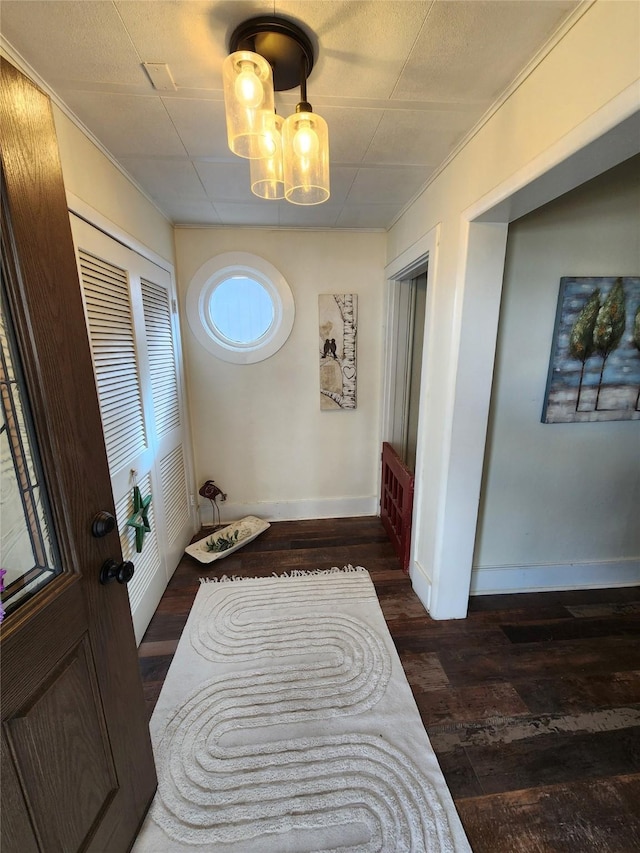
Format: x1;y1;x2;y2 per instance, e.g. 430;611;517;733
470;559;640;595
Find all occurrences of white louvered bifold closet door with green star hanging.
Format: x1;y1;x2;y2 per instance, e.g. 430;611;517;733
71;215;195;642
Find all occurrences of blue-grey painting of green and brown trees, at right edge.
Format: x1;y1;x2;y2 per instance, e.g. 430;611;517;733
542;276;640;423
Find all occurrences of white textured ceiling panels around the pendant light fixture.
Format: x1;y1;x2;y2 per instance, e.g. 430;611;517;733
0;0;582;228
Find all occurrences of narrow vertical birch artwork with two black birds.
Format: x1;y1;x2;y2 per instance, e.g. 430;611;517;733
318;293;358;410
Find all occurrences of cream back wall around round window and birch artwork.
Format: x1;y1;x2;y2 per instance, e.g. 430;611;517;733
176;228;385;523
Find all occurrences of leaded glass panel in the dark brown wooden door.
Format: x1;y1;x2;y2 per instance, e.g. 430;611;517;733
0;276;61;620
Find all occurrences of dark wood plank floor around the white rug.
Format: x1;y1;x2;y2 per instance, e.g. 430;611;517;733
139;518;640;853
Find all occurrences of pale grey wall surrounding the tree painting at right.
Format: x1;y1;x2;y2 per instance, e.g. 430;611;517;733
472;157;640;592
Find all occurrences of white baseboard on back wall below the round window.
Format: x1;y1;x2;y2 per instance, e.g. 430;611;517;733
199;495;379;525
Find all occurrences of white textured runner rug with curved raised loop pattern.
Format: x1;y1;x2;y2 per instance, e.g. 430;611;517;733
133;566;471;853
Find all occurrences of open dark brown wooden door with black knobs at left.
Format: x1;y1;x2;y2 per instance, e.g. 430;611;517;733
0;59;156;853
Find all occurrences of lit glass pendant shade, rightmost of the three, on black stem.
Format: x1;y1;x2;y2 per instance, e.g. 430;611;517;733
282;104;330;204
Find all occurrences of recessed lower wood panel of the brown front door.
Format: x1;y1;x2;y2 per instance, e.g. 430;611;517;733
5;637;117;851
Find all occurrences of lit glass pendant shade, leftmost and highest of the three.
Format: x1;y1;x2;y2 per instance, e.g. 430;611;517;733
222;50;275;159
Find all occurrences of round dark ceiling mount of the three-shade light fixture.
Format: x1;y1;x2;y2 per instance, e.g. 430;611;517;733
229;15;315;92
